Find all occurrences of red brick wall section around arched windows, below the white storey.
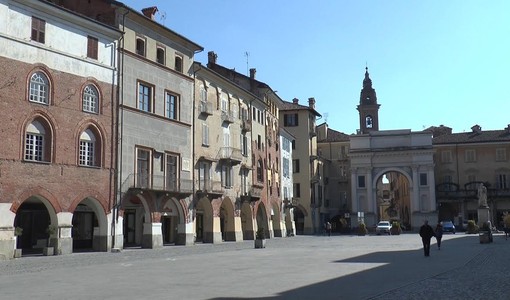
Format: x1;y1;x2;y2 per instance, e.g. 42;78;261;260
0;57;115;212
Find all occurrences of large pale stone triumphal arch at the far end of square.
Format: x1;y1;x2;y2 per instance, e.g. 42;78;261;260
349;129;437;231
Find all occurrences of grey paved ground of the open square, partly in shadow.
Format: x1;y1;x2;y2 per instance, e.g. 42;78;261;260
0;234;510;300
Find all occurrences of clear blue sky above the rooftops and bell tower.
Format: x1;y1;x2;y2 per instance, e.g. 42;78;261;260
121;0;510;134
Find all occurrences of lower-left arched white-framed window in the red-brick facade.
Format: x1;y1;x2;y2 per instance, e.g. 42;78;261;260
25;120;51;161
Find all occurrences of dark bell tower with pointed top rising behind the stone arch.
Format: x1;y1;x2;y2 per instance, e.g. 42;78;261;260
357;67;381;134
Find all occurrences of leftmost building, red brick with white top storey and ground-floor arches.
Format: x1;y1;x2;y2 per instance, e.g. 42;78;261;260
0;0;120;258
